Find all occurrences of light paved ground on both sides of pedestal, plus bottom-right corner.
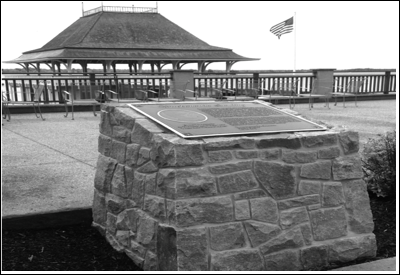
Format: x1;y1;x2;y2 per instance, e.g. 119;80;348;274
1;100;398;271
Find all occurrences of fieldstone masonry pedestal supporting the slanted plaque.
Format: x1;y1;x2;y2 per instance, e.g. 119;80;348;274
93;106;376;271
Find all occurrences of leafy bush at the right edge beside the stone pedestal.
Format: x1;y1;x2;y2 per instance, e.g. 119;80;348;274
362;130;396;198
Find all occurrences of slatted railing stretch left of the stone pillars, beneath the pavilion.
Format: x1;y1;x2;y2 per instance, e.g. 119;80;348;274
1;74;170;103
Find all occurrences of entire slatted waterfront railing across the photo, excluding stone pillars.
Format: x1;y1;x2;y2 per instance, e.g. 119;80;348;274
1;71;396;103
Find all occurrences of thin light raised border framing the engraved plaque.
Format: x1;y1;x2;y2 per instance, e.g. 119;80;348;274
127;100;328;138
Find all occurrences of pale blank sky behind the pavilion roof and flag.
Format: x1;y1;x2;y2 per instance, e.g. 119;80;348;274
1;1;399;70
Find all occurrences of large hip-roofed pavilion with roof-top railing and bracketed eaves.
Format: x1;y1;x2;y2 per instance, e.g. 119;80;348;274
6;6;259;73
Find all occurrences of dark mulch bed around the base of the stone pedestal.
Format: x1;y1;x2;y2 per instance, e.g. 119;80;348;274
1;195;396;271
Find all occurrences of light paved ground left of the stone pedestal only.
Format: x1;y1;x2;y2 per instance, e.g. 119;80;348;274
1;112;100;219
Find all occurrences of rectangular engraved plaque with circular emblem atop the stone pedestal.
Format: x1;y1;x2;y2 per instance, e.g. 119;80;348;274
129;101;326;138
